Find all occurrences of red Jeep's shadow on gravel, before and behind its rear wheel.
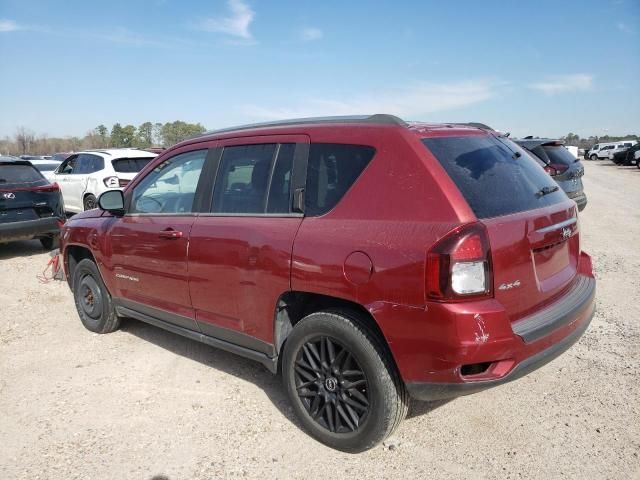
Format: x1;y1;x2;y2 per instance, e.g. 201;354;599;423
120;319;451;430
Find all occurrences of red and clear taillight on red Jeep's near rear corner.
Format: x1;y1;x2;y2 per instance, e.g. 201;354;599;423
426;223;493;301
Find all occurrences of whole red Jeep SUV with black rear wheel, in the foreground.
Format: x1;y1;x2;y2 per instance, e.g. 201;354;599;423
61;115;595;452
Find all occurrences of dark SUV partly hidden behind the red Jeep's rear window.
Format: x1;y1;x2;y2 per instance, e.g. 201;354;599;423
515;138;587;211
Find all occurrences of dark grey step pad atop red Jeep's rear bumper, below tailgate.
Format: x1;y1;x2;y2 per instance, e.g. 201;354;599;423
512;276;596;343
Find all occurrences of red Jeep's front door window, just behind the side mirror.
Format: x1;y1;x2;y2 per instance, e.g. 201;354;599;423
129;150;207;213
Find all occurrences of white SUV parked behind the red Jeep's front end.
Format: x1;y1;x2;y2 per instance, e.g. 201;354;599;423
51;148;157;213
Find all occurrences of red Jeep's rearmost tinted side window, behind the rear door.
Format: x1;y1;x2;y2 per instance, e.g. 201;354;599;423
304;143;375;216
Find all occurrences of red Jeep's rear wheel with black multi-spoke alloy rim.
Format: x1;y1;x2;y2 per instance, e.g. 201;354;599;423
282;311;409;453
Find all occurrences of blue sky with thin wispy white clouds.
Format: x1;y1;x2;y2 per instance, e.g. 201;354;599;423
0;0;640;136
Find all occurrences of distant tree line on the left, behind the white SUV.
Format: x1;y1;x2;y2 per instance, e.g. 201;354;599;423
0;120;206;155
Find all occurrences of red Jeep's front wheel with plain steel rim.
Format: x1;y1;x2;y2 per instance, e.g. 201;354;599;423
73;258;120;333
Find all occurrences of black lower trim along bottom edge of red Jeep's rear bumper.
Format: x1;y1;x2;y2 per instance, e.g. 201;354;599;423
406;307;595;401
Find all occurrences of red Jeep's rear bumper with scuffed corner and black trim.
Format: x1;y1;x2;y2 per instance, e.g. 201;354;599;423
370;252;596;401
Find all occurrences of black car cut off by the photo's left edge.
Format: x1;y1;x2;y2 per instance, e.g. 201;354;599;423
0;157;65;250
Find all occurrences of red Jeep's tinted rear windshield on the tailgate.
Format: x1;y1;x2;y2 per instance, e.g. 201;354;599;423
422;135;566;218
